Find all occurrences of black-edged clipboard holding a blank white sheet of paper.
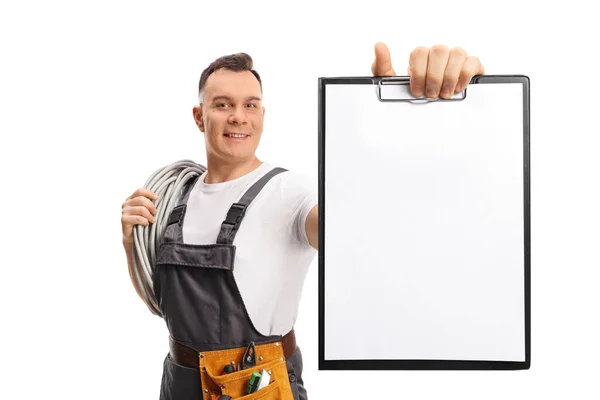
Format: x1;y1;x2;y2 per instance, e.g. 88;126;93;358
318;75;531;370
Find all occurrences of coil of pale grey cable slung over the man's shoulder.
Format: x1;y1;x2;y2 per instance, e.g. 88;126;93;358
129;160;206;317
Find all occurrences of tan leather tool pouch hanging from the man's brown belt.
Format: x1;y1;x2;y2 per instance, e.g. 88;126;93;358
200;342;294;400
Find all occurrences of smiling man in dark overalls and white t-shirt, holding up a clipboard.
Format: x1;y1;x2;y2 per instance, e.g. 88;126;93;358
121;43;484;400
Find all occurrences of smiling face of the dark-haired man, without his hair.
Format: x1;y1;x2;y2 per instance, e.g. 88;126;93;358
194;69;265;162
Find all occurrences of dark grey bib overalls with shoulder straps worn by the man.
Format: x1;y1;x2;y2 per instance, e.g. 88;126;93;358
153;168;307;400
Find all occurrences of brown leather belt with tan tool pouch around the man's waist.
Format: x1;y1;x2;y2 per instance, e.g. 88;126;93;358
170;329;296;400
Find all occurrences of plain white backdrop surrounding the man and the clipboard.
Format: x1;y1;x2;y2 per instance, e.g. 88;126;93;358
0;1;600;399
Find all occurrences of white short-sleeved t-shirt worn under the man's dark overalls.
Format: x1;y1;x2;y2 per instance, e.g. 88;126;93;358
182;162;318;335
